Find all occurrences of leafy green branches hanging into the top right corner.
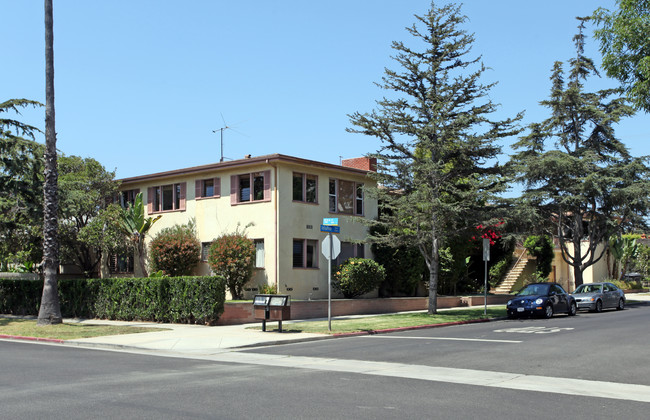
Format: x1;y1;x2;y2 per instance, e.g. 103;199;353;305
593;0;650;112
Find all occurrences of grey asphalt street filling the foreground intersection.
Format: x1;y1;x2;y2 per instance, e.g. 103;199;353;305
0;306;650;419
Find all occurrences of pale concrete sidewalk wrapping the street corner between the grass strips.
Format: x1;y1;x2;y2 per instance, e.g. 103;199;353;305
6;293;650;355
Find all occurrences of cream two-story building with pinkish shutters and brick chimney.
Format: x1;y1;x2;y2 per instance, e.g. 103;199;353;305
120;154;377;299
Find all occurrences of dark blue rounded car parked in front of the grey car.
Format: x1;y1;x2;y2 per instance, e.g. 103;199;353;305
506;283;577;318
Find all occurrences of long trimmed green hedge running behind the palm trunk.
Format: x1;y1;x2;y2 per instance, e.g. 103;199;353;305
0;276;226;325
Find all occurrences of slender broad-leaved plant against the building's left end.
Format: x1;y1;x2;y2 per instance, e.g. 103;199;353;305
120;193;162;277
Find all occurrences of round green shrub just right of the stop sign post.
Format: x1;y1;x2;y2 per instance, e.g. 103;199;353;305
334;258;386;298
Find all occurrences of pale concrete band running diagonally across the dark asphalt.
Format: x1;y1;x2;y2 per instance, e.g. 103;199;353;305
204;352;650;402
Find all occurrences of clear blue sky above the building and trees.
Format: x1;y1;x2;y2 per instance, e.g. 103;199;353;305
0;0;650;184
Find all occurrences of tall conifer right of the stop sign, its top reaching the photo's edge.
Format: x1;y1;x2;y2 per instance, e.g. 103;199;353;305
348;3;520;314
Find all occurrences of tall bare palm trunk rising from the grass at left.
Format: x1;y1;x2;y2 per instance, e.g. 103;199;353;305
37;0;63;325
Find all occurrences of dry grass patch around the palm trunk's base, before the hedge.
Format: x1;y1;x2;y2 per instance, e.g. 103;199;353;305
0;318;166;340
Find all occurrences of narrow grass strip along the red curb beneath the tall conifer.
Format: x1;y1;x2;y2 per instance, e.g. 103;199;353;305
251;306;506;334
